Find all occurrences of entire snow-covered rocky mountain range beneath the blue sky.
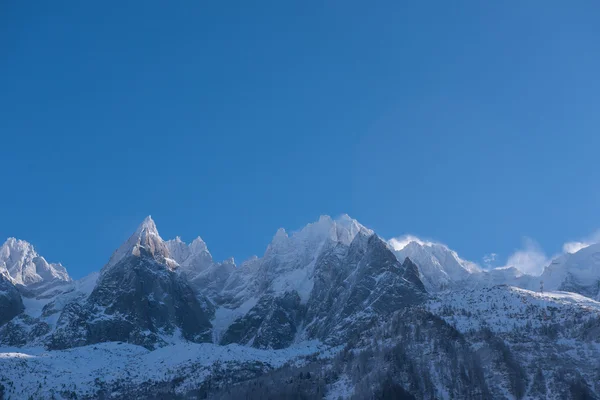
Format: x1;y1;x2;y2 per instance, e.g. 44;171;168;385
0;215;600;399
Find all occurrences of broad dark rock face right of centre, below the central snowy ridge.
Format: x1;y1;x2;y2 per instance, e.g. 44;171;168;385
306;234;427;343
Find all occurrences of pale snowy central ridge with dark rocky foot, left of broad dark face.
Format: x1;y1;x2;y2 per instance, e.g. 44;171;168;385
213;216;378;348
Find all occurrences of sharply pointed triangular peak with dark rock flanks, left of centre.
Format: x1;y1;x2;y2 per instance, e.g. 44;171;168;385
50;218;214;348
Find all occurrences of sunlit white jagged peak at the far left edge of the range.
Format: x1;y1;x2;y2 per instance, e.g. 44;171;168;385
0;238;71;286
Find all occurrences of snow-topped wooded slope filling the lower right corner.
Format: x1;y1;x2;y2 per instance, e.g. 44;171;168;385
428;286;600;400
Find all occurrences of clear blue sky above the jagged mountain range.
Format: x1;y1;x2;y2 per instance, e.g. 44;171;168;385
0;0;600;278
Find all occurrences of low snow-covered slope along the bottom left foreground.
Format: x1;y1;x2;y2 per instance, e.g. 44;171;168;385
0;342;323;399
